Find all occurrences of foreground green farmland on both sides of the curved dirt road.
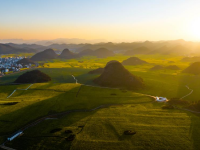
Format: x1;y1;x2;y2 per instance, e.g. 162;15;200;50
0;84;200;150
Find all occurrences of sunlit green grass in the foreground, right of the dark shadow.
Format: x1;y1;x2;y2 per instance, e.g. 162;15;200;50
71;104;200;150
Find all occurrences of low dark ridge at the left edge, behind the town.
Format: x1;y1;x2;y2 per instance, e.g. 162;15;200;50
0;44;39;54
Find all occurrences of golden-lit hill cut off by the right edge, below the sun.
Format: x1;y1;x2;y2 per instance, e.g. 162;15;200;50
182;62;200;75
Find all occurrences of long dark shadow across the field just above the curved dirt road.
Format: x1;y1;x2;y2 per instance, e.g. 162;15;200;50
0;87;84;135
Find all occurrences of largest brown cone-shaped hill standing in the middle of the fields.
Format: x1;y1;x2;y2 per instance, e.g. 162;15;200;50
94;61;144;89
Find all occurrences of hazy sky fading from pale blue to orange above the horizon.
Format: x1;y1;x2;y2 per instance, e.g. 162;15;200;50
0;0;200;41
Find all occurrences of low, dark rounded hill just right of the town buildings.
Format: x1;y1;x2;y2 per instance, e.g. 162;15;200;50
15;70;51;83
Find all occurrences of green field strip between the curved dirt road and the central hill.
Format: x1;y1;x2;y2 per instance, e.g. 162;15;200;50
0;83;151;143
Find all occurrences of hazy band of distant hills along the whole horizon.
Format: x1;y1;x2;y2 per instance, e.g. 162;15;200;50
0;40;200;56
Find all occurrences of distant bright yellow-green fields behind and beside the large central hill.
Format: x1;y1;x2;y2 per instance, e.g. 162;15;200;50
0;55;200;101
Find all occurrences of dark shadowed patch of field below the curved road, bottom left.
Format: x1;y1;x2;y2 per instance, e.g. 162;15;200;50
7;109;93;150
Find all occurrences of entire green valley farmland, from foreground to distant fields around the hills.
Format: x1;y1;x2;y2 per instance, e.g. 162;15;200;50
0;55;200;150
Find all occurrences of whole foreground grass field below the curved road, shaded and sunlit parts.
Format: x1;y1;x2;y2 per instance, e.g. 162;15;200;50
5;103;200;150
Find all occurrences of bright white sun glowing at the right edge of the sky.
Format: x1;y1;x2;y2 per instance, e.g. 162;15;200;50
188;17;200;40
